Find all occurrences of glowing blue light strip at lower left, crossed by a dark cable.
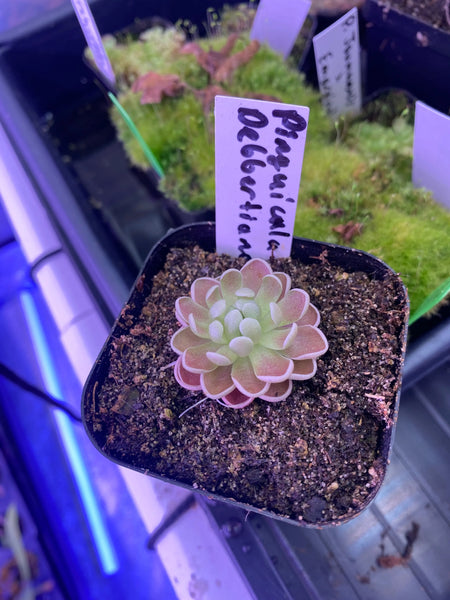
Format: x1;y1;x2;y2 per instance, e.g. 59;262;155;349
20;291;118;575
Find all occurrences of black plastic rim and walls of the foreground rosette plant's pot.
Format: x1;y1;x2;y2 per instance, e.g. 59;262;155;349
82;223;408;527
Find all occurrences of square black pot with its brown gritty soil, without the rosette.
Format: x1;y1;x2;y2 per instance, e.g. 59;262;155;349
82;223;409;527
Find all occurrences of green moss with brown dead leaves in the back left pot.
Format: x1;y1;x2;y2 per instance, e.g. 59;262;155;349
107;28;330;211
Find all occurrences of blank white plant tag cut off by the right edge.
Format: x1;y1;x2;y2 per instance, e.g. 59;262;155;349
412;102;450;208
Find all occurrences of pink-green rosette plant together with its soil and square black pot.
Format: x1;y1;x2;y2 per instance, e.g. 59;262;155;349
83;223;408;526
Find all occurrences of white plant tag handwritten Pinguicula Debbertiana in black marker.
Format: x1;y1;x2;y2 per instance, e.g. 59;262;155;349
215;96;309;258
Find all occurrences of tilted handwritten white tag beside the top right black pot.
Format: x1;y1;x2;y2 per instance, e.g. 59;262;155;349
313;8;362;118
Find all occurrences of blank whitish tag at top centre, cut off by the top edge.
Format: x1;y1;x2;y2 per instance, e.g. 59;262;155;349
250;0;311;58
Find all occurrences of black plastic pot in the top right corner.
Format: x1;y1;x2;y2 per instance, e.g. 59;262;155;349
362;0;450;114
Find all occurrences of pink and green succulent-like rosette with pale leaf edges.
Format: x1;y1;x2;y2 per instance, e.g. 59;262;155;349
171;258;328;408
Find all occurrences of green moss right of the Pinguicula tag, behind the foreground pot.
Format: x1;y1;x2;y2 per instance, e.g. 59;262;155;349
295;115;450;311
